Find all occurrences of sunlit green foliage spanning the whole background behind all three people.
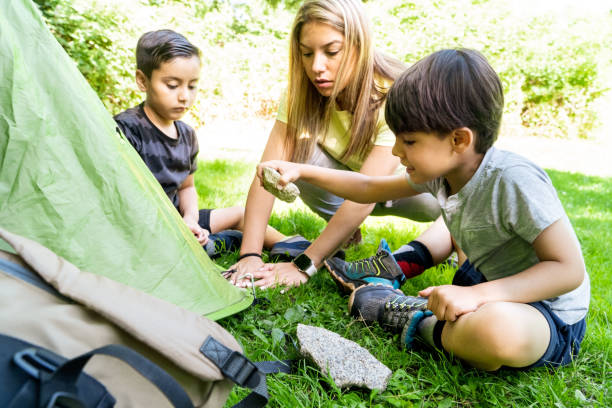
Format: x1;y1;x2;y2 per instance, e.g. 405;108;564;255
36;0;612;138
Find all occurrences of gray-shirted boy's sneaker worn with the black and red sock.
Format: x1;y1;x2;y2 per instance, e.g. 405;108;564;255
325;239;406;293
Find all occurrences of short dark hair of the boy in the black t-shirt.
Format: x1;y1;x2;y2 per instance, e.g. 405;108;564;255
136;30;200;78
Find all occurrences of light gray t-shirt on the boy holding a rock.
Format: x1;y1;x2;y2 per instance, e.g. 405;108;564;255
407;147;590;324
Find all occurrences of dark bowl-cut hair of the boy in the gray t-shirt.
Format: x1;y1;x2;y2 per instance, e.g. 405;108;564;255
385;49;504;153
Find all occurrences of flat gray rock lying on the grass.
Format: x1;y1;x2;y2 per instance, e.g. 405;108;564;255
297;324;392;391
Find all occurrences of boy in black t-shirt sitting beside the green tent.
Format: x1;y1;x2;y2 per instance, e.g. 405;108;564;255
115;30;285;256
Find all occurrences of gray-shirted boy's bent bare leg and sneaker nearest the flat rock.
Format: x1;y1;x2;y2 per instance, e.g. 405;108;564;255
349;278;551;371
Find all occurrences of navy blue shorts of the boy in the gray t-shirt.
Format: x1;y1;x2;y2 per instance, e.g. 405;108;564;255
453;261;586;370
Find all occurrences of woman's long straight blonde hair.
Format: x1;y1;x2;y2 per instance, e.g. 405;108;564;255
285;0;405;162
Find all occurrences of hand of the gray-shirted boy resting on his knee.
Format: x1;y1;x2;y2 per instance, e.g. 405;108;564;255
419;285;481;322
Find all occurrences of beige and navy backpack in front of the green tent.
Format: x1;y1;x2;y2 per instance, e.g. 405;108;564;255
0;228;289;407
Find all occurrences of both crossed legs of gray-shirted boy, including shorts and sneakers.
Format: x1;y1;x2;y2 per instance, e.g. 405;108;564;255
326;222;584;371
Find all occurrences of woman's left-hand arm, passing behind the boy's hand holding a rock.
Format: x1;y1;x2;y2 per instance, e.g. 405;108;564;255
232;120;289;283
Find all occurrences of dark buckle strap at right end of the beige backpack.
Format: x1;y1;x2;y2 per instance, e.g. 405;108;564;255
200;336;291;408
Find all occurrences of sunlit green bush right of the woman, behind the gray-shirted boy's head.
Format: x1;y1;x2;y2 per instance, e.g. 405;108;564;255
371;0;612;138
